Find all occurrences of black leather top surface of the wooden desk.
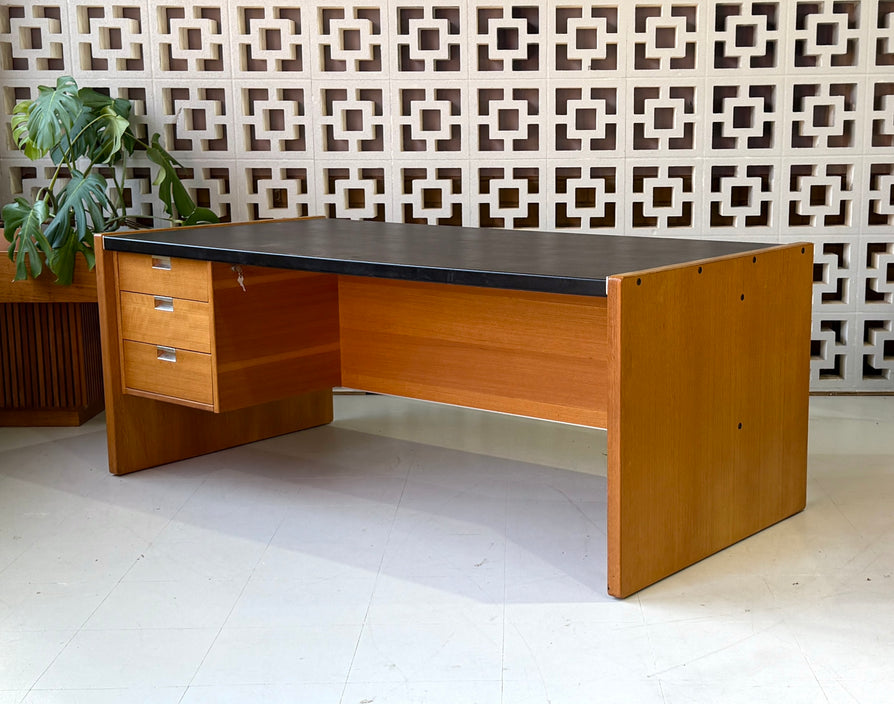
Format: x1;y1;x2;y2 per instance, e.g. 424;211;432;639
104;219;775;296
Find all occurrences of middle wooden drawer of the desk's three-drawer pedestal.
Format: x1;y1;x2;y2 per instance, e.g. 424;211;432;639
120;291;211;353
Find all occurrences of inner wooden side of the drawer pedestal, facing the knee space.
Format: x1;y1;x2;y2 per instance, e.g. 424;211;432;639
213;263;341;410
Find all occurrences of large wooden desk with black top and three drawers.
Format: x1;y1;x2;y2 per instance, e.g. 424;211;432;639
97;219;813;597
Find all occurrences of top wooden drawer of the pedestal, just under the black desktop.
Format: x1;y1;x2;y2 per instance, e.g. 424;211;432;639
117;252;211;301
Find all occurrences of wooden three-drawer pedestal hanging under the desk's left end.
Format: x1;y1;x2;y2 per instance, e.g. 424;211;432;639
115;252;340;413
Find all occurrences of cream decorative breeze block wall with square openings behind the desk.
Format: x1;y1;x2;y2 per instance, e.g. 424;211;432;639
0;0;894;392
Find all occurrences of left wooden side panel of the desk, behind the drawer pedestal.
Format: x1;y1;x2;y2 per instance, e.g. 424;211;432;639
95;236;332;474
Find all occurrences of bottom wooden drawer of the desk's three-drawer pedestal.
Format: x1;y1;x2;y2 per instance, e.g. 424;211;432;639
124;340;214;406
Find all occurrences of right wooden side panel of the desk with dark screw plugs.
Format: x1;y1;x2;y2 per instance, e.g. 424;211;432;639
608;244;813;597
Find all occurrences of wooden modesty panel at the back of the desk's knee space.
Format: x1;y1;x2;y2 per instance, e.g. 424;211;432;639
339;277;608;426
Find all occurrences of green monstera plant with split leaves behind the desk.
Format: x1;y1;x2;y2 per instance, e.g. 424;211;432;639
2;76;218;284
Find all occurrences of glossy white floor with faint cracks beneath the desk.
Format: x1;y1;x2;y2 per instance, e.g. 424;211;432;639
0;396;894;704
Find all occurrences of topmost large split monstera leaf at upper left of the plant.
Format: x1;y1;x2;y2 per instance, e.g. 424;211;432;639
19;76;83;159
